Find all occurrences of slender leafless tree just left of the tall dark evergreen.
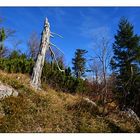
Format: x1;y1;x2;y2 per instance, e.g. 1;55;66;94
92;37;112;112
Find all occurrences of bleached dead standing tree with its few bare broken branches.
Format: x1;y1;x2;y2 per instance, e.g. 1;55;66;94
31;18;64;89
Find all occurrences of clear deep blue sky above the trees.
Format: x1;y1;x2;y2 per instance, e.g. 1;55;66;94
0;7;140;66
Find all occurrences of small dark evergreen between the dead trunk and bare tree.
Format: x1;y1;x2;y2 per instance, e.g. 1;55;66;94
72;49;87;78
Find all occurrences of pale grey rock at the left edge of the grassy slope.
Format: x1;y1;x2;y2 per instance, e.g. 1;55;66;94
0;81;18;99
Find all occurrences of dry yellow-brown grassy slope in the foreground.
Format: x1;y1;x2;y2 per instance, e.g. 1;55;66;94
0;71;136;132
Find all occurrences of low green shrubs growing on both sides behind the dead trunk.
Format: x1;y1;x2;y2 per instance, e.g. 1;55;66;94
0;51;95;94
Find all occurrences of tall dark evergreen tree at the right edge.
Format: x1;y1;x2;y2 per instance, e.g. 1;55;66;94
111;18;140;114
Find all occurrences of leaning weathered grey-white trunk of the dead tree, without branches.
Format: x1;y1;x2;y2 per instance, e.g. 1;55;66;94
31;18;50;89
